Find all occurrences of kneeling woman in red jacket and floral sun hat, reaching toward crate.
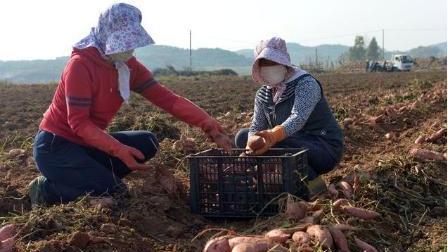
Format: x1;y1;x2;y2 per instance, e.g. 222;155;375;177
29;3;231;206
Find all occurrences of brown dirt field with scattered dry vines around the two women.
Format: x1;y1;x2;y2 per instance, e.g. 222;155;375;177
0;71;447;251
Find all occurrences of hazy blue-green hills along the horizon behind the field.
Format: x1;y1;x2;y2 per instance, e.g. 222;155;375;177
0;42;447;83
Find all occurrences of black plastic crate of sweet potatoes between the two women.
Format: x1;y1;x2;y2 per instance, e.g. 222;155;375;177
188;148;308;217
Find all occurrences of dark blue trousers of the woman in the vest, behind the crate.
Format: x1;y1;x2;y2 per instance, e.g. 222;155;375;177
235;129;339;180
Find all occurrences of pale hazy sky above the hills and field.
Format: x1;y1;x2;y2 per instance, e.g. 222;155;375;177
0;0;447;60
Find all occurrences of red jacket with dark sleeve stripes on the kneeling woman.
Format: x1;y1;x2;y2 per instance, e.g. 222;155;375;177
39;47;210;154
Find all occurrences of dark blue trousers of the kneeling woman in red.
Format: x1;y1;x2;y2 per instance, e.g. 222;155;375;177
33;130;159;204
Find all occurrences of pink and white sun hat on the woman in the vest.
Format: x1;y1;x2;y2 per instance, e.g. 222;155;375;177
252;37;294;84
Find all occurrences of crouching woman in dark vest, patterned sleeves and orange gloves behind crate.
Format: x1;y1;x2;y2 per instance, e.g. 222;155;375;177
235;37;344;180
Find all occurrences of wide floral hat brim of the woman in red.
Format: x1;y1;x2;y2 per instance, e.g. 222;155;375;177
104;24;154;55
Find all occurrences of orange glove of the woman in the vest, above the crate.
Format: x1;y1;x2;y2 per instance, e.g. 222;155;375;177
247;125;286;155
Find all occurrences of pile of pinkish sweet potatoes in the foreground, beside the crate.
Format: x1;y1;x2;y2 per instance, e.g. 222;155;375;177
203;175;381;252
